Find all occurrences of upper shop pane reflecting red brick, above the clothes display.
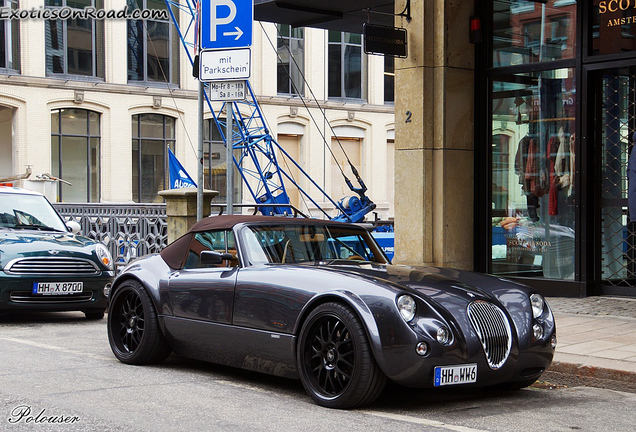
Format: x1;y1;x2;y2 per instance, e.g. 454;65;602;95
492;0;576;67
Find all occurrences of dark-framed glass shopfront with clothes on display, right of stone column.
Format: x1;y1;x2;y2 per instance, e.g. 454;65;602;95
475;0;636;296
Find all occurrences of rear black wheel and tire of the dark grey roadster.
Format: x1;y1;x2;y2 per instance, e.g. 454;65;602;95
107;280;171;365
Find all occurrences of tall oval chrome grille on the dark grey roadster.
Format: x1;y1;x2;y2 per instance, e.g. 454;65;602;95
468;300;512;369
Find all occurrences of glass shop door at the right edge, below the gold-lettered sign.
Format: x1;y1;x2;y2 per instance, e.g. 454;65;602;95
595;66;636;296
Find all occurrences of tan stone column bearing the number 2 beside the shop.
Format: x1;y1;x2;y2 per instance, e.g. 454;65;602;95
395;0;474;269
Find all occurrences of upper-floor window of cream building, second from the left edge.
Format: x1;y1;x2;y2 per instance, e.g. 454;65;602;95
45;0;105;79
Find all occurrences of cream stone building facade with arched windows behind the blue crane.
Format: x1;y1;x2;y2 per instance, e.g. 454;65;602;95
0;0;395;219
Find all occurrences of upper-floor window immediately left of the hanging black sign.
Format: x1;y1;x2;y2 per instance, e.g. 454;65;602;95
328;30;366;100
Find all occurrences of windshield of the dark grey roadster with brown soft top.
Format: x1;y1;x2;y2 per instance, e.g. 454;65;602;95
243;224;388;265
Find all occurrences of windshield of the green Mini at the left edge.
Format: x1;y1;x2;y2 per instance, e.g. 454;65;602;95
0;193;67;231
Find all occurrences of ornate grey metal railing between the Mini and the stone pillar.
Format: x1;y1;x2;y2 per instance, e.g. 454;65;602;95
53;203;168;266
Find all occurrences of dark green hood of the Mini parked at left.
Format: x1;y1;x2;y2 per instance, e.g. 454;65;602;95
0;229;95;268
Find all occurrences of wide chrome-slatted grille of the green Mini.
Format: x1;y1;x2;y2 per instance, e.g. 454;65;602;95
5;257;99;276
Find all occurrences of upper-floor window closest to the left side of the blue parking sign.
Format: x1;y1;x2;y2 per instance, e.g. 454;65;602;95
128;0;180;86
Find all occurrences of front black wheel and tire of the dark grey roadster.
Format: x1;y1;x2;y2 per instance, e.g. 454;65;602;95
297;303;387;409
